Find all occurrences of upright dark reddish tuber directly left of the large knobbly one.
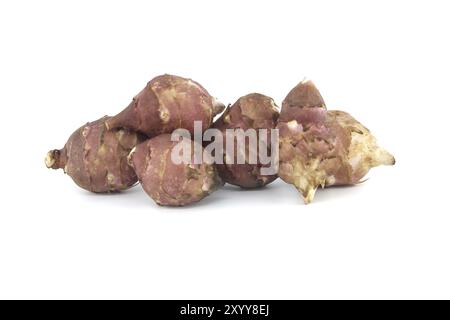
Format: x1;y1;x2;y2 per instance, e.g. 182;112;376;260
214;93;279;188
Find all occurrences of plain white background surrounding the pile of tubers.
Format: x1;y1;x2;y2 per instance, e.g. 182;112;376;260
0;0;450;299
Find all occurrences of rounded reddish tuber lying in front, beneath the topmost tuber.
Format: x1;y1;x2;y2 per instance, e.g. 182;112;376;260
129;134;223;206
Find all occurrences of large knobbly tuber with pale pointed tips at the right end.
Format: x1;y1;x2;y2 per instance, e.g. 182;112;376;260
277;81;395;203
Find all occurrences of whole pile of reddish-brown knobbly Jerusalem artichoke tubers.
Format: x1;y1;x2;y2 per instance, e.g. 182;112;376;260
45;74;395;206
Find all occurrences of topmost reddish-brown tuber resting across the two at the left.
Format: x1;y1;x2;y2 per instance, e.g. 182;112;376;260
106;74;225;137
